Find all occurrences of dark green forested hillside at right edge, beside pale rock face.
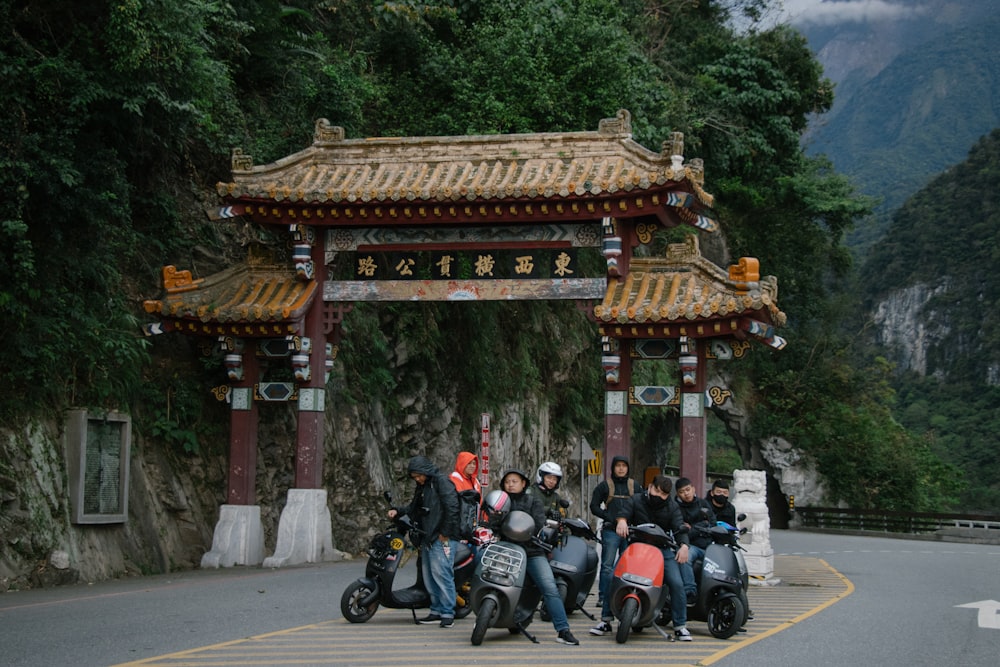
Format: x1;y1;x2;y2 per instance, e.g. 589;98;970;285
861;129;1000;512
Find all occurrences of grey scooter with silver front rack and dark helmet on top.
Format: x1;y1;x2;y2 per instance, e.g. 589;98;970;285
470;511;551;646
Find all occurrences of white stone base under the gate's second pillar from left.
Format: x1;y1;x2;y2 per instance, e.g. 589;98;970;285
264;489;344;567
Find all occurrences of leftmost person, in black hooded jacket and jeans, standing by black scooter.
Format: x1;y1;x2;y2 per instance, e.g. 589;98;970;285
389;456;458;628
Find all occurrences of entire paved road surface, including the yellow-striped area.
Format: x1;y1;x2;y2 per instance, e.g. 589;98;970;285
0;531;1000;667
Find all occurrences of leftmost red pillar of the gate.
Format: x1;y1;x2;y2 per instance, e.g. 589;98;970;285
226;340;260;505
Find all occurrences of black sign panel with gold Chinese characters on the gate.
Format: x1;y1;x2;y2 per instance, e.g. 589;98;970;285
354;248;580;280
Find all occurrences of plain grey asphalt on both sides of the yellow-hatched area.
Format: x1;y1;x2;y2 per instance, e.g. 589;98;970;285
0;531;1000;667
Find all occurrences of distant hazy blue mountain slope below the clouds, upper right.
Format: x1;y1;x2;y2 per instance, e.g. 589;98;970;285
808;11;1000;256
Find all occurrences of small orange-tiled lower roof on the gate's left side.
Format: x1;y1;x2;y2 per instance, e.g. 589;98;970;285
143;263;318;337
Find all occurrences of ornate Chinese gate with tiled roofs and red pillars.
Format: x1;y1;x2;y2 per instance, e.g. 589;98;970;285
147;111;784;566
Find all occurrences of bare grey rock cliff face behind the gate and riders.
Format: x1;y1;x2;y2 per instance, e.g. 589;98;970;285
0;370;580;592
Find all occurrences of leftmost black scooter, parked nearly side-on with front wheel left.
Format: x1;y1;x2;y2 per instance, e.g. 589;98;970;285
340;493;475;623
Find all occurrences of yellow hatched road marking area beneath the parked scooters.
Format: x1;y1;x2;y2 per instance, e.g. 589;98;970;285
116;556;854;667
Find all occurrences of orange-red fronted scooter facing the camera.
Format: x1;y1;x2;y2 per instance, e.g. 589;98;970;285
608;523;676;644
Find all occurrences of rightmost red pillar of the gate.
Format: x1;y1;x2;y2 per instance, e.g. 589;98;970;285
680;338;708;495
